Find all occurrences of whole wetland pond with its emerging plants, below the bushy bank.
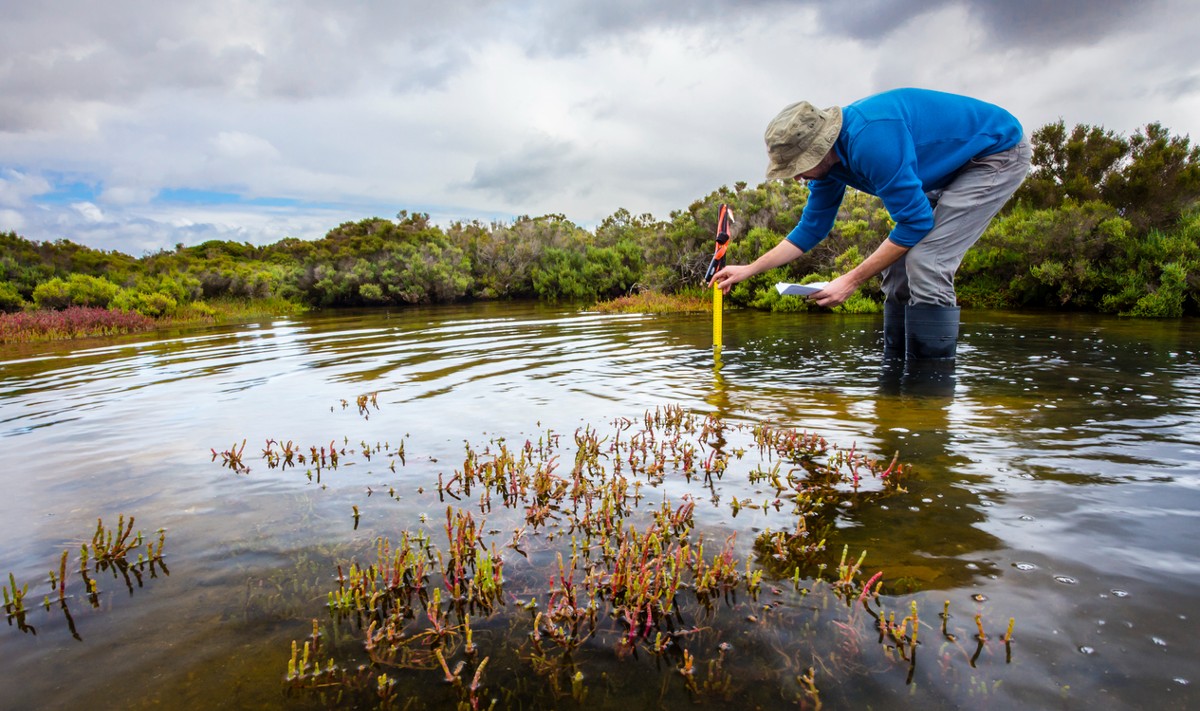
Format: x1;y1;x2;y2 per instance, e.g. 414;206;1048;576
0;304;1200;710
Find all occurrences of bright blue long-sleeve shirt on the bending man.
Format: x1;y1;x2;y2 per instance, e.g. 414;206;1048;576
787;89;1024;252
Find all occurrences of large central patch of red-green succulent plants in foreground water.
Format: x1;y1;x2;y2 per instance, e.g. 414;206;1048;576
211;408;1010;709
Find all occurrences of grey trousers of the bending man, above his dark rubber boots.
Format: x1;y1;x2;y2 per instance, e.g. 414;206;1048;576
882;141;1032;306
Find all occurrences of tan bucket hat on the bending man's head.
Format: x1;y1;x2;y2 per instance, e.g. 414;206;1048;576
764;101;841;180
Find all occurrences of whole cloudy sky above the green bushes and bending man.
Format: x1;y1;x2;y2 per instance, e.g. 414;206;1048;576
0;0;1200;255
